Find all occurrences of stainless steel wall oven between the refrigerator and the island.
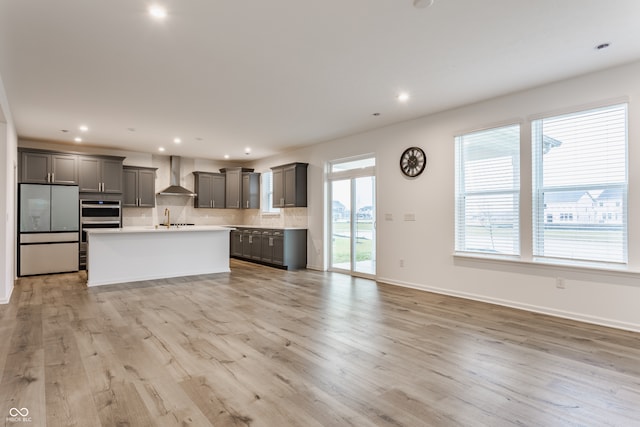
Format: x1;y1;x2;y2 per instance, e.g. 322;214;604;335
80;199;122;270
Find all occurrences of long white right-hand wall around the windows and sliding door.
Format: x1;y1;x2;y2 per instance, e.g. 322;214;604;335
251;63;640;331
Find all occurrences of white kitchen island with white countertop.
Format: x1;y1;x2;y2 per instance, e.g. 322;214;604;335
87;225;231;286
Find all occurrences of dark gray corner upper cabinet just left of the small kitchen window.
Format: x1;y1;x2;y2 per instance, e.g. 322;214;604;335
220;168;260;209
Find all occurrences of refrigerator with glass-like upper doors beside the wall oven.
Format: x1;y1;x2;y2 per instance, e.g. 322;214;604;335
18;184;80;276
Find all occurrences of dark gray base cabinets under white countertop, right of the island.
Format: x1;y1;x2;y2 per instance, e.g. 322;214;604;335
230;228;307;270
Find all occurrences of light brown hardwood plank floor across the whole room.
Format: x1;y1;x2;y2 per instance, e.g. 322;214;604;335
0;261;640;427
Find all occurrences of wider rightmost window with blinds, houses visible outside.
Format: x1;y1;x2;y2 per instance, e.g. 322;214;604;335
532;104;627;263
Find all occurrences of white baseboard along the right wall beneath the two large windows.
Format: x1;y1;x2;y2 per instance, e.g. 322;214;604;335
376;277;640;332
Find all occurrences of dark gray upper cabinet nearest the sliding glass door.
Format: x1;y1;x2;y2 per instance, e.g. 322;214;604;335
271;163;309;208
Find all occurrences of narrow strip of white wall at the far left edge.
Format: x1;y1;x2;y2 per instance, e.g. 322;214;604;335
0;72;18;304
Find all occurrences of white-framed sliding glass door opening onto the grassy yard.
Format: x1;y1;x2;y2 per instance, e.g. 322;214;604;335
329;157;376;276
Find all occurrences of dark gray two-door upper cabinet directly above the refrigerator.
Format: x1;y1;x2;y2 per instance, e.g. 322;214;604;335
20;151;78;184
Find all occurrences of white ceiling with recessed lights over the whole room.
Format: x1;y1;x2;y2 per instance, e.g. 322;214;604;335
0;0;640;160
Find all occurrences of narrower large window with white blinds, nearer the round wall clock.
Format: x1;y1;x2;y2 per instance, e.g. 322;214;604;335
456;125;520;255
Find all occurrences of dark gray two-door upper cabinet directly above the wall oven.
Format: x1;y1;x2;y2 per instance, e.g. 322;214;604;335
79;156;124;194
